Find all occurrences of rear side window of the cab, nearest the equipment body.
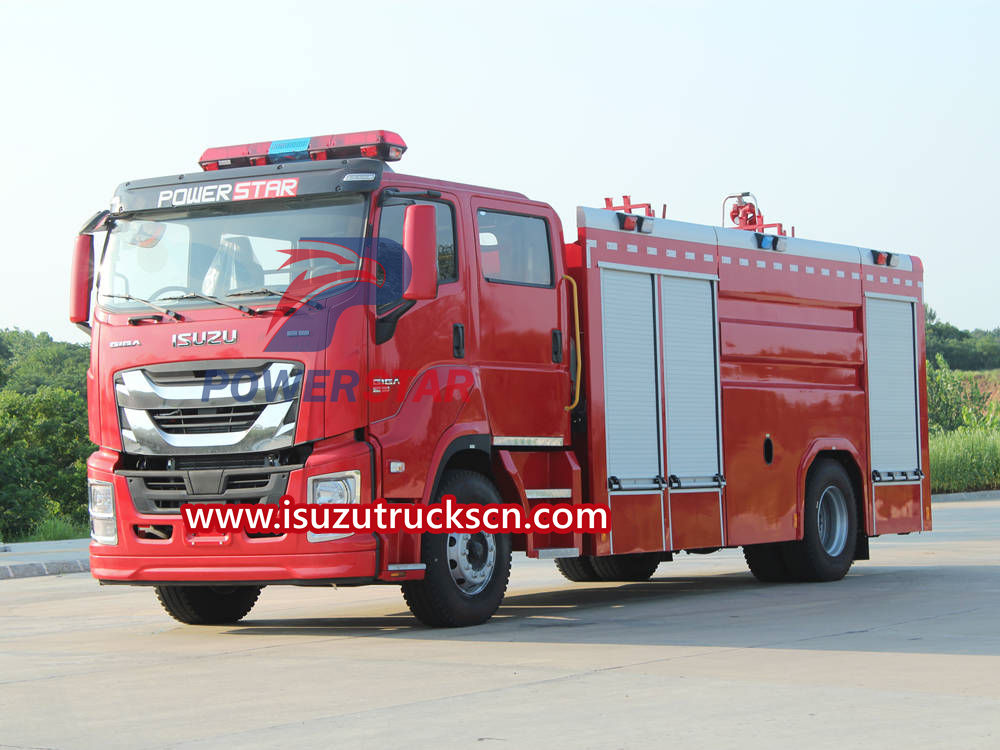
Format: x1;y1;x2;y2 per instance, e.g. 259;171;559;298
476;209;552;286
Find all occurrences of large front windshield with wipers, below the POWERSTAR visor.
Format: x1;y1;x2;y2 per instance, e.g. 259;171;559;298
98;195;366;309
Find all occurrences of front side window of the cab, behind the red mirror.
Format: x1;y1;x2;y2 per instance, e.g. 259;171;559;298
375;200;458;309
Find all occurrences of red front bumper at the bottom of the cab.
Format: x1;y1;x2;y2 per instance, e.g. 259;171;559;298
87;440;381;585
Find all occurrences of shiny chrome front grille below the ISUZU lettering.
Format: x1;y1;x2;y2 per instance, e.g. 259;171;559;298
115;359;303;456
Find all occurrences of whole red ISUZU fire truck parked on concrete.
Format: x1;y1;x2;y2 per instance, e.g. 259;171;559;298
70;131;931;626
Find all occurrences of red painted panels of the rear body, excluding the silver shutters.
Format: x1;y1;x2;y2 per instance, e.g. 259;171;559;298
568;210;931;555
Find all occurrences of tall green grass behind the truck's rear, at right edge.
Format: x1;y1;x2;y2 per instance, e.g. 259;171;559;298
930;429;1000;492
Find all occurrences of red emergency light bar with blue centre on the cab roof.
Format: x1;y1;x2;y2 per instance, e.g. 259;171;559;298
198;130;406;172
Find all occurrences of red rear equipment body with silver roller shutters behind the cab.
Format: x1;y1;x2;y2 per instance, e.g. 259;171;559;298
568;209;930;554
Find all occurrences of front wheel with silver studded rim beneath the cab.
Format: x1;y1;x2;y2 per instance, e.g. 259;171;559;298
402;470;511;628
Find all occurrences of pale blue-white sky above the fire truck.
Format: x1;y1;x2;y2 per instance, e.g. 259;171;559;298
0;0;1000;342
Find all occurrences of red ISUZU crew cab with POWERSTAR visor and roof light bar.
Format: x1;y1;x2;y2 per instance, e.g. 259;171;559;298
71;131;579;624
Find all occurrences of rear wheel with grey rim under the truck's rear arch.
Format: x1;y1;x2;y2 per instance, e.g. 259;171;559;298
781;459;858;581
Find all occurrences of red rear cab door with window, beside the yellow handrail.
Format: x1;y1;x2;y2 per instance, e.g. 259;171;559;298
472;199;570;446
